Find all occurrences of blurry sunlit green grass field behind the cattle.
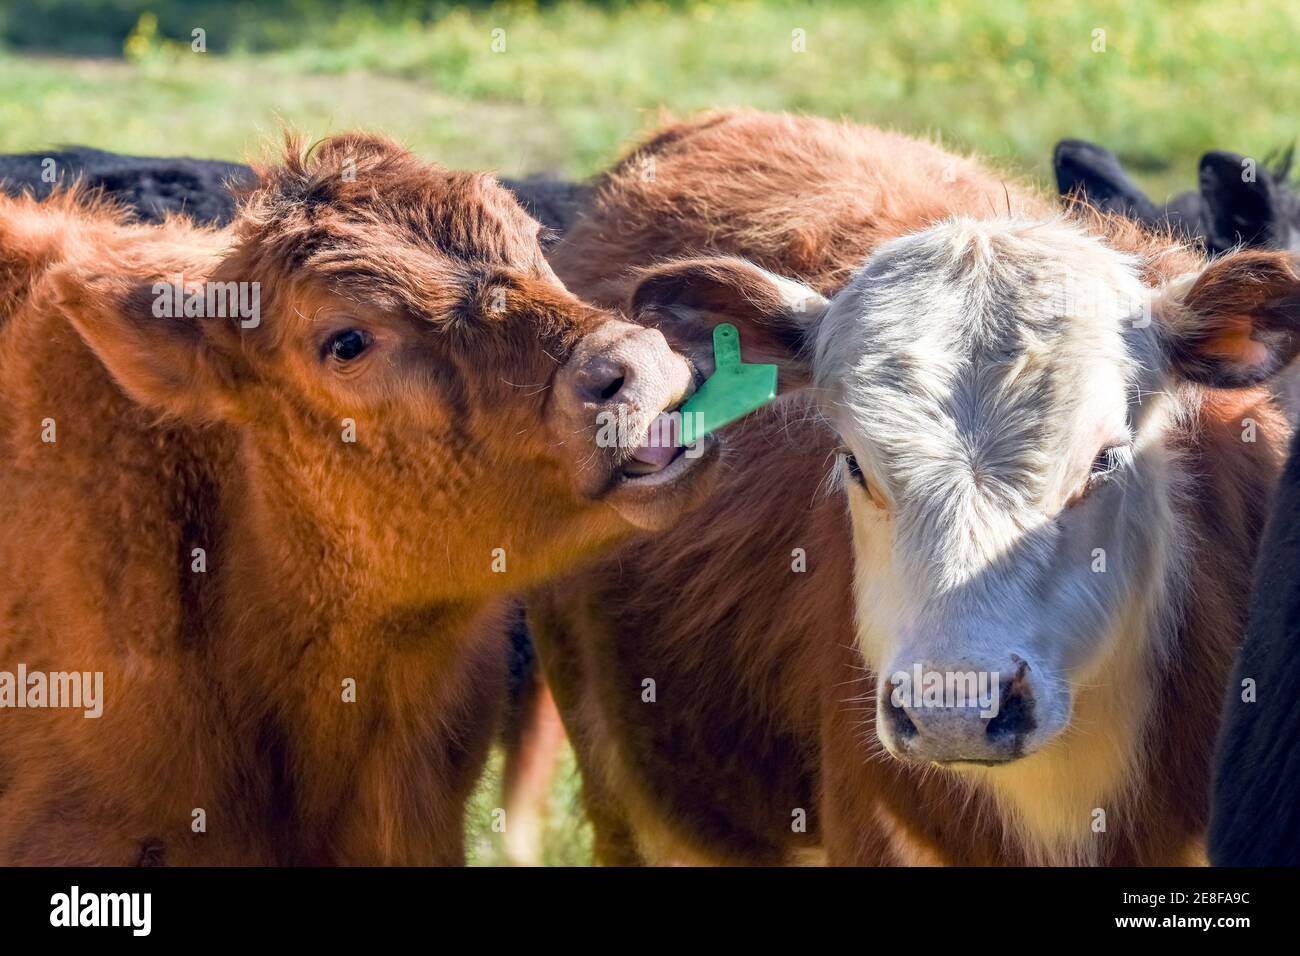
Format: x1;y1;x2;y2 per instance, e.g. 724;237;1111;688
0;0;1300;864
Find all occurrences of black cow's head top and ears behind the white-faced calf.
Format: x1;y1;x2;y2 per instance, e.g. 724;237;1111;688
1052;139;1300;255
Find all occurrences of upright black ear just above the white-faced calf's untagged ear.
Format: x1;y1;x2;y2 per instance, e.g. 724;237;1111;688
1200;151;1282;255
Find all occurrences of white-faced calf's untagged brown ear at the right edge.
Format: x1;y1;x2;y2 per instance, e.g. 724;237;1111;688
1156;250;1300;388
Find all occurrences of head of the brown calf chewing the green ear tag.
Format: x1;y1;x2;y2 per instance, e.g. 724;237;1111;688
55;134;711;601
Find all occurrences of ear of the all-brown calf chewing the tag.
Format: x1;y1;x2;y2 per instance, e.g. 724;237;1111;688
49;268;249;423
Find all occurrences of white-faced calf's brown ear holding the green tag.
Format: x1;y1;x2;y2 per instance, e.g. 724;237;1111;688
628;256;828;392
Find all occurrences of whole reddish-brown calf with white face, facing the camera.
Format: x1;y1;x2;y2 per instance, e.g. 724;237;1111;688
532;113;1295;864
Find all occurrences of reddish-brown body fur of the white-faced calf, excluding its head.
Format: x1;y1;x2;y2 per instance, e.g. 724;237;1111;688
532;113;1284;864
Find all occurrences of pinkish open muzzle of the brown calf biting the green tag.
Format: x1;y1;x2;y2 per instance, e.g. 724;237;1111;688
550;319;716;529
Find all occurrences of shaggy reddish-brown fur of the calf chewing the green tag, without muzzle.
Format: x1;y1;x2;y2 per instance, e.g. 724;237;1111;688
0;134;686;865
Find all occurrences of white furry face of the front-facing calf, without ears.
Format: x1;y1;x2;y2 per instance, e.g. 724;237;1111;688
814;220;1178;773
